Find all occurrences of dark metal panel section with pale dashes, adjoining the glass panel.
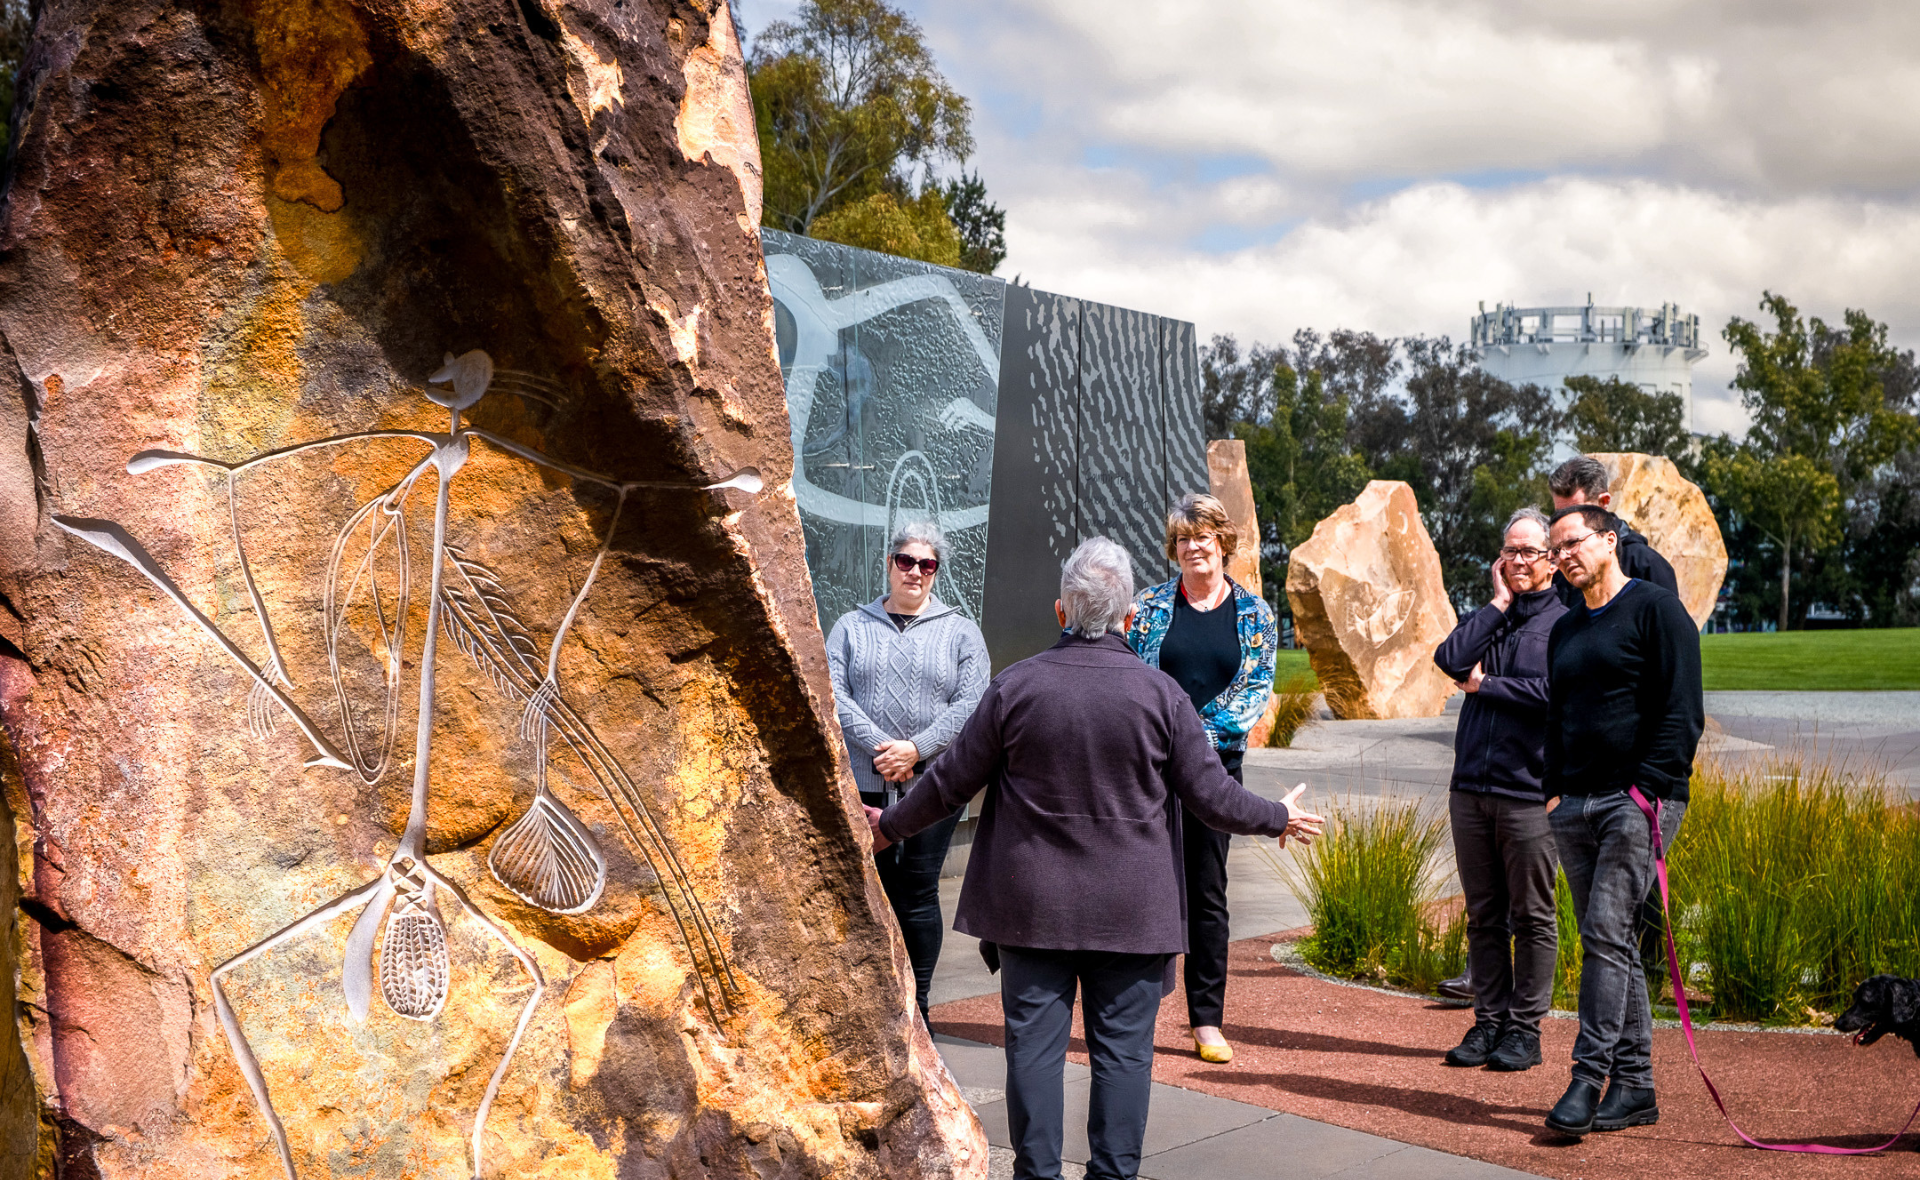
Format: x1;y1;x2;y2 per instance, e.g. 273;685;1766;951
985;286;1083;672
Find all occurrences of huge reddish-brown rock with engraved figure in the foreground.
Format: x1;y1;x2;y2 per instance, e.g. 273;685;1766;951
0;0;987;1180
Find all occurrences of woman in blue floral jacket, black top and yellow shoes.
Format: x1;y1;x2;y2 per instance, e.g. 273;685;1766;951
1127;493;1281;1063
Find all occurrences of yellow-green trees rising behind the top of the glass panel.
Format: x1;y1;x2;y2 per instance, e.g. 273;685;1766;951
747;0;1006;274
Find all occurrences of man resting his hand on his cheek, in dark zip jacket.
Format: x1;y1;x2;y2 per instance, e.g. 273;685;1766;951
1434;508;1567;1071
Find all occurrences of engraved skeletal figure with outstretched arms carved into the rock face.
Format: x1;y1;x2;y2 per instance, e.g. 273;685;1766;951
54;349;762;1180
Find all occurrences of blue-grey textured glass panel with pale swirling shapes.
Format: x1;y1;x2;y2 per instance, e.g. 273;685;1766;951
760;230;1006;627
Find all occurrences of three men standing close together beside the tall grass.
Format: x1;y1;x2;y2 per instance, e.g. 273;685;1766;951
1434;455;1705;1136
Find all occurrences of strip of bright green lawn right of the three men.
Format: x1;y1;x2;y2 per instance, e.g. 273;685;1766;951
1699;627;1920;691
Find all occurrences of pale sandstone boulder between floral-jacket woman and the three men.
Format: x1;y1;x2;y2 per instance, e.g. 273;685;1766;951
1286;480;1457;721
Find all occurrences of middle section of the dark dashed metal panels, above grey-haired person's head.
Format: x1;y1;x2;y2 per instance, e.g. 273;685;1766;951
1077;303;1171;587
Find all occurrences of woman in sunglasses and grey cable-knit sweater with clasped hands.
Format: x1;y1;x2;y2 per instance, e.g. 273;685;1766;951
828;522;993;1019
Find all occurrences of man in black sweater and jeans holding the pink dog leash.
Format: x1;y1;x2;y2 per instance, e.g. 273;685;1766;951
1546;505;1705;1136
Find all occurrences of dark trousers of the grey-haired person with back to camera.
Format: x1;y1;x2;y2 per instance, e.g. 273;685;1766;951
1000;946;1167;1180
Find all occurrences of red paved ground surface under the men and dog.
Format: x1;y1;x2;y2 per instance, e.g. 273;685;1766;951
933;936;1920;1180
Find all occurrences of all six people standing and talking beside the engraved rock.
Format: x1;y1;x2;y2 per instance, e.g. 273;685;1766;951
828;459;1703;1180
